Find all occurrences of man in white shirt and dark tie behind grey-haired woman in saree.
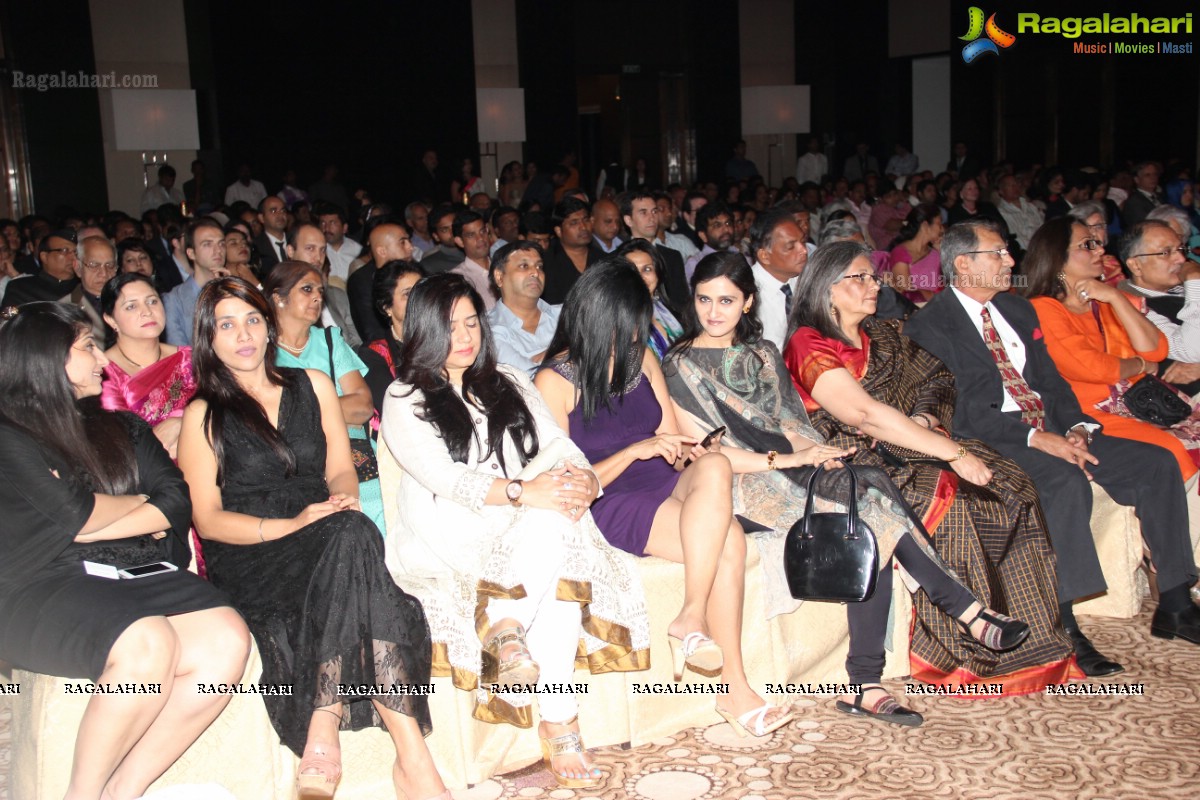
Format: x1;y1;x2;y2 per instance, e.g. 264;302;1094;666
750;209;809;353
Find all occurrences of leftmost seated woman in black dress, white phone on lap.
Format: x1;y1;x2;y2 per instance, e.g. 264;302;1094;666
0;302;250;800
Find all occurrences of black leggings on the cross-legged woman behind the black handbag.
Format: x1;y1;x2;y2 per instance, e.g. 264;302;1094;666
846;534;977;684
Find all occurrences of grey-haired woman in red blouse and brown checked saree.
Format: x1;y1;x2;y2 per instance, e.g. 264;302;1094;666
784;242;1079;694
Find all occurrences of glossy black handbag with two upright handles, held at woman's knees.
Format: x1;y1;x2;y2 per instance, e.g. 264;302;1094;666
784;464;880;603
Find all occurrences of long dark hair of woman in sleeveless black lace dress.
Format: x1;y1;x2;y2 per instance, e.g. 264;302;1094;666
192;277;296;486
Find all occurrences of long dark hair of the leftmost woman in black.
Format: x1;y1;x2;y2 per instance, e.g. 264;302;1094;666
0;302;138;494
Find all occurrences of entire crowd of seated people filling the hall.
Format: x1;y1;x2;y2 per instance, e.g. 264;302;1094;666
7;151;1200;800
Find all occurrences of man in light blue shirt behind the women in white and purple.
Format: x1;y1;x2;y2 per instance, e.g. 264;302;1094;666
487;241;563;375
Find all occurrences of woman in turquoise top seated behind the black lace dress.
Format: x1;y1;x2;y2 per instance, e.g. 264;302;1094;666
263;261;388;535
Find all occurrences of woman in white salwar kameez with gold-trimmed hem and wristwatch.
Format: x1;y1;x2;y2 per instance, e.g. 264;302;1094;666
382;275;649;788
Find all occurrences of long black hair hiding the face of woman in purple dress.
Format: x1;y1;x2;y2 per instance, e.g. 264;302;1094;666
544;255;654;423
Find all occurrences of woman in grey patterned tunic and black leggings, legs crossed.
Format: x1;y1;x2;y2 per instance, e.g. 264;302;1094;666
664;253;1041;726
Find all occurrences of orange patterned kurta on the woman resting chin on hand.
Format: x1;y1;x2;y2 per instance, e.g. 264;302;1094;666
1032;297;1196;481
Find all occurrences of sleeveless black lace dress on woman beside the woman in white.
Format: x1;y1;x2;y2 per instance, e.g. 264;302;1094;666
204;369;432;754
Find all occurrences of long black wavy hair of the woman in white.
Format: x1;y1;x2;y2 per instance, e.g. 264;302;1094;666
396;272;540;471
